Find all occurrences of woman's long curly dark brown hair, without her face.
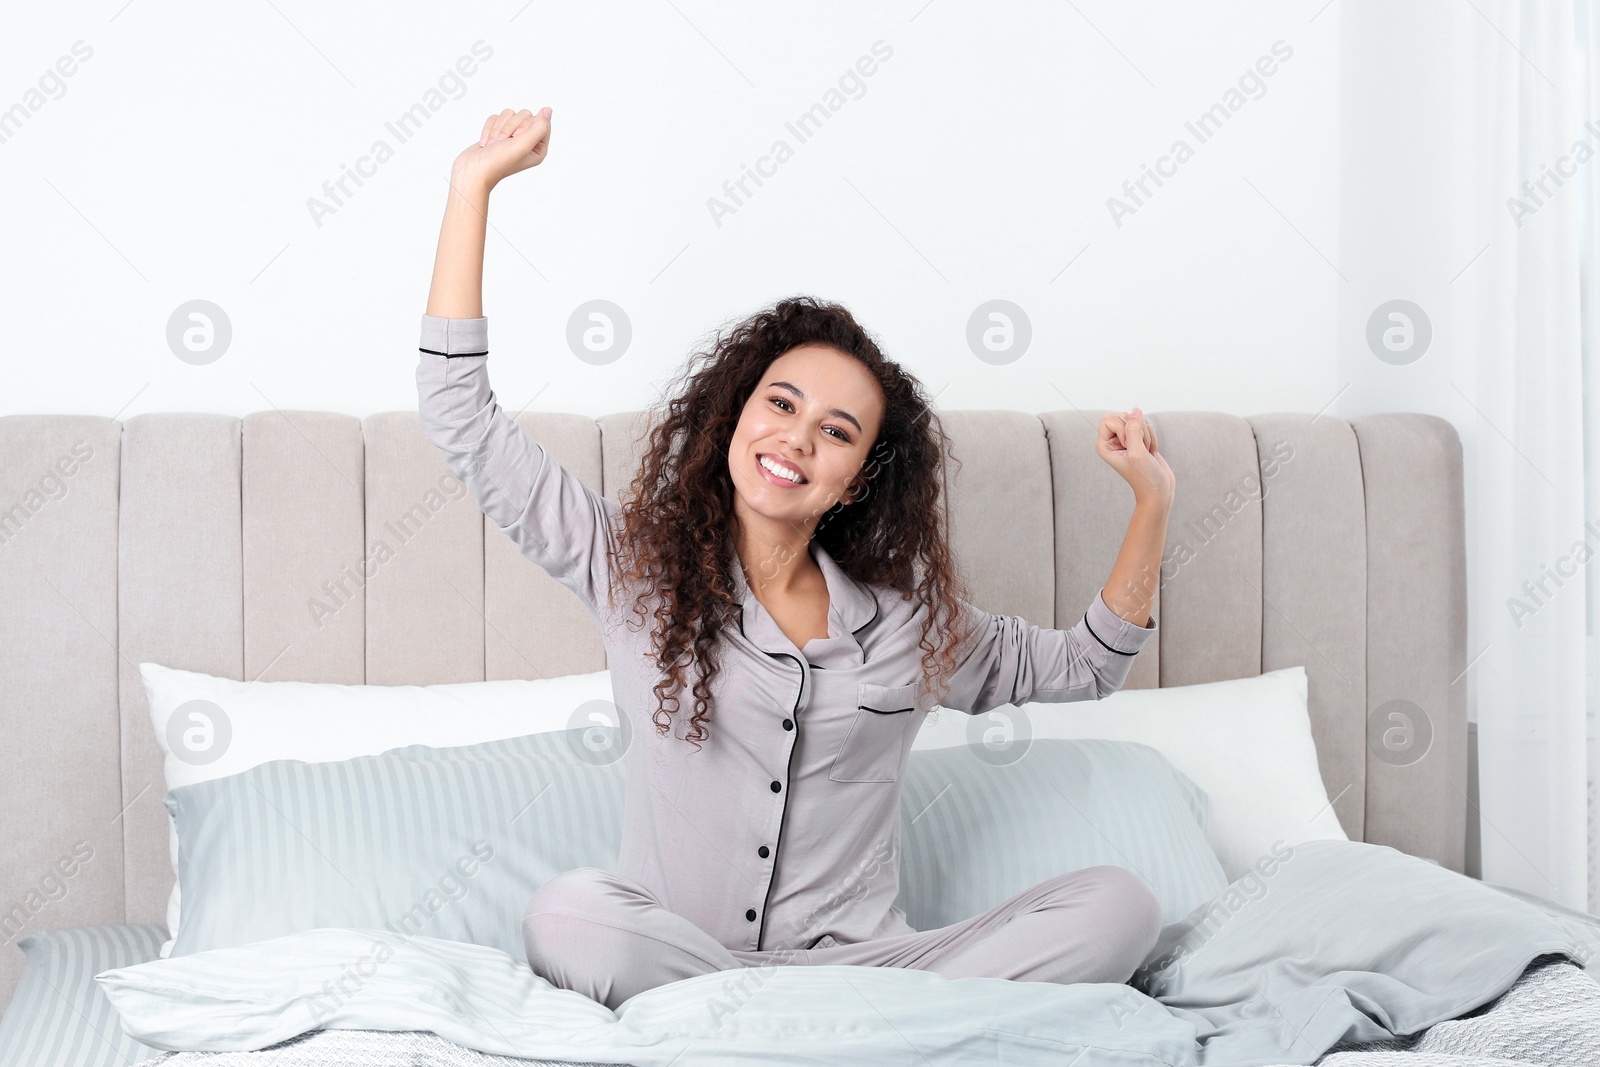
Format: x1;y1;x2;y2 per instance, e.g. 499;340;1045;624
606;296;970;749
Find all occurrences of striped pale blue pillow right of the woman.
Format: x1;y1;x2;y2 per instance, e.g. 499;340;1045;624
896;737;1227;929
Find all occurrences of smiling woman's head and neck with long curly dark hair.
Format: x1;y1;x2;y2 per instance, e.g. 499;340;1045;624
618;296;992;741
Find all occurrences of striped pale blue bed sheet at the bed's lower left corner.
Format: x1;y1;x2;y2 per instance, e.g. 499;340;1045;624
0;925;166;1067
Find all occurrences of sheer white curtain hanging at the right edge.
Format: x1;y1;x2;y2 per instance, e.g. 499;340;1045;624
1451;0;1600;913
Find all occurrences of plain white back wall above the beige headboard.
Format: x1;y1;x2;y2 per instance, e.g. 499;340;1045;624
0;0;1337;418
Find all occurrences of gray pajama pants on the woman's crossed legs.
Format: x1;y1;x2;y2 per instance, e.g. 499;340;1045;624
522;865;1162;1008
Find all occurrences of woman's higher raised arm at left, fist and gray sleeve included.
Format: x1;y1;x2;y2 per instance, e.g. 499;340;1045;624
416;109;618;621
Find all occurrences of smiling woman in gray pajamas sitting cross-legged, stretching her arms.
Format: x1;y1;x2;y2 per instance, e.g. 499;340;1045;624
418;107;1174;1008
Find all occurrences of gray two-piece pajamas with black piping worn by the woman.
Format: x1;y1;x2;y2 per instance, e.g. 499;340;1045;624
416;315;1155;1003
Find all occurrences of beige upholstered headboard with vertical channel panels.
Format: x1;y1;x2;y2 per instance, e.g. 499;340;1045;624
0;411;1467;1003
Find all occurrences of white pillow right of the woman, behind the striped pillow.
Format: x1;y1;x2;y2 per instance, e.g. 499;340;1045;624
912;667;1349;881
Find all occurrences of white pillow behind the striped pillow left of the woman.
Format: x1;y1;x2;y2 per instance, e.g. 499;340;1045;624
139;662;619;957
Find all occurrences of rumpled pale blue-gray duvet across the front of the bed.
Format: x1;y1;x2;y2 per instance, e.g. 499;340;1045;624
98;841;1600;1067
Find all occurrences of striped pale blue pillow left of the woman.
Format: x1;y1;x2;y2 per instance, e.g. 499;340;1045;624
166;728;624;961
